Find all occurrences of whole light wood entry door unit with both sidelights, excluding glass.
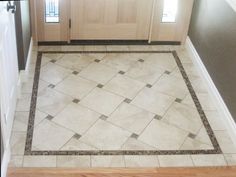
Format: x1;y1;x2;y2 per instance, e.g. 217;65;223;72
31;0;194;42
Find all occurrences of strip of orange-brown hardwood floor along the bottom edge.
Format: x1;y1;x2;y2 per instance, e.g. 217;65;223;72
8;166;236;177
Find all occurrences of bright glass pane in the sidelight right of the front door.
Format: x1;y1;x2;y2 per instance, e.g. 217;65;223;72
162;0;178;23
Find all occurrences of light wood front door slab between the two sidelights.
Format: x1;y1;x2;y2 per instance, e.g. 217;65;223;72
71;0;153;40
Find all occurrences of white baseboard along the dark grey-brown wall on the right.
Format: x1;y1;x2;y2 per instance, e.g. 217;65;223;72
185;37;236;145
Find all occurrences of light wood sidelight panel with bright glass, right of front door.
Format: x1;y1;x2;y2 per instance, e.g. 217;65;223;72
150;0;194;43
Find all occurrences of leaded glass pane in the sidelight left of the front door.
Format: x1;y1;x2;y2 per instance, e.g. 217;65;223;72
45;0;59;23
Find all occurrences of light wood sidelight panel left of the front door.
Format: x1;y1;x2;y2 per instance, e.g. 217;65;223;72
34;0;70;42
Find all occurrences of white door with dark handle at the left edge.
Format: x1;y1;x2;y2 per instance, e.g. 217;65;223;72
0;1;19;168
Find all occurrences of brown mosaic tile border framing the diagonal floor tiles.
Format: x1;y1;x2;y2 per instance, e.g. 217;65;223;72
25;51;222;155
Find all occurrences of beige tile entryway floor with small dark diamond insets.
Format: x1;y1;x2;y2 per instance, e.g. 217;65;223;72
10;46;236;167
